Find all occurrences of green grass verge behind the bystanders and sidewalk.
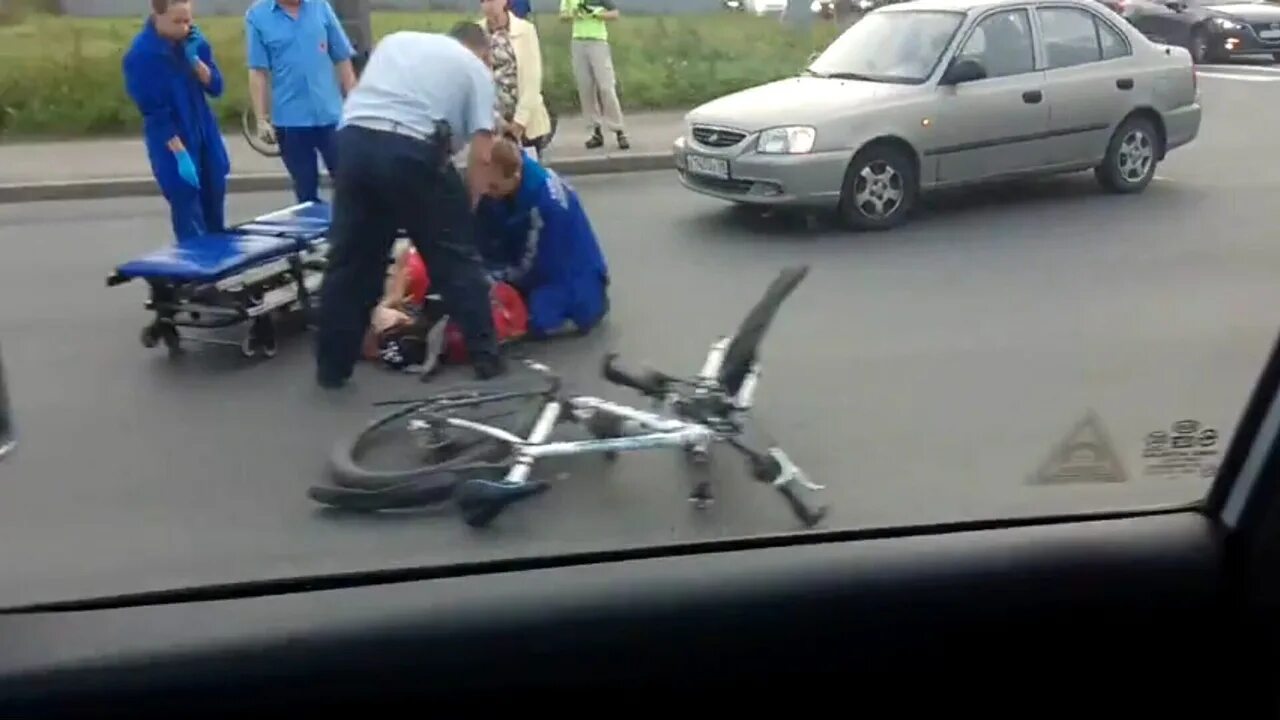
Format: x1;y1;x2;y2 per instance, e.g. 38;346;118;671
0;12;835;138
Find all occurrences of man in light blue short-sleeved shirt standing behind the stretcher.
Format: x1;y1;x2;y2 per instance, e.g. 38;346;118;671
244;0;356;202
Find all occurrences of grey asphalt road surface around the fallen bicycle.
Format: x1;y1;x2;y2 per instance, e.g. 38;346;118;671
0;67;1280;606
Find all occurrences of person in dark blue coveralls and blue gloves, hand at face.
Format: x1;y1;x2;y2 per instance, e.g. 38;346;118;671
123;0;230;240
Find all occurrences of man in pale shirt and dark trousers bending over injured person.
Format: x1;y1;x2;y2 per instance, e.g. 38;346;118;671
316;22;504;388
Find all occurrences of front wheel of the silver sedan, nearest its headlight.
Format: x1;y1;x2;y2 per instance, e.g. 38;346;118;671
840;142;919;231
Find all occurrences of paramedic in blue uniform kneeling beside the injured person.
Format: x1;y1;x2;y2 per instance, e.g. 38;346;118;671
477;141;609;338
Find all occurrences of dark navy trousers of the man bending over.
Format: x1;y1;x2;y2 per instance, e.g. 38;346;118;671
316;126;498;383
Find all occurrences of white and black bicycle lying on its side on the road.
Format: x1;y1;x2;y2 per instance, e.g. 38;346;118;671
308;266;826;527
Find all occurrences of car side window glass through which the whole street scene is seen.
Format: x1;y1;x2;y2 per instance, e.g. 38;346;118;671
0;0;1264;609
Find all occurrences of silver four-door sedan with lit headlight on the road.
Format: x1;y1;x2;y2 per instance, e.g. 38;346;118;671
675;0;1201;229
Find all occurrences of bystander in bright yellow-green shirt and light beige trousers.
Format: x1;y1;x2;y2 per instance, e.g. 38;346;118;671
561;0;631;150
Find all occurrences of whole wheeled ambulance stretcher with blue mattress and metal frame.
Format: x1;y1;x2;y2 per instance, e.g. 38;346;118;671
106;202;332;357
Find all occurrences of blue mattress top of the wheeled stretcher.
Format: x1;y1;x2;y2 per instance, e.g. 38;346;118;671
115;202;330;282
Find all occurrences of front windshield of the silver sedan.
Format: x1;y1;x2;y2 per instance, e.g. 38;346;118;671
809;10;964;83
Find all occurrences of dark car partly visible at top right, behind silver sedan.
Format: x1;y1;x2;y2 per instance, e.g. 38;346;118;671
1112;0;1280;63
